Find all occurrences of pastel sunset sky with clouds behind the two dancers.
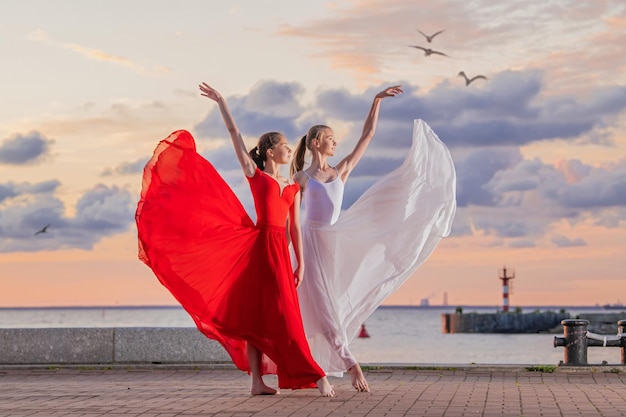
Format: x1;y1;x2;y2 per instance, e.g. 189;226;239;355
0;0;626;307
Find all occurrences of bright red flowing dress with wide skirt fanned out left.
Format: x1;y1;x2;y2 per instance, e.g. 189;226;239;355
135;130;325;389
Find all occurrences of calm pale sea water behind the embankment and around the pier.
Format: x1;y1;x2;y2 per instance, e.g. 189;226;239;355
0;306;621;366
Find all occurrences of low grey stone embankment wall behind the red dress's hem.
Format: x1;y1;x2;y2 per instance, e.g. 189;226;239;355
0;327;232;365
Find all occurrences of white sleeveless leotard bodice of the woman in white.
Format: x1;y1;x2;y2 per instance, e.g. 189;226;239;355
302;171;344;225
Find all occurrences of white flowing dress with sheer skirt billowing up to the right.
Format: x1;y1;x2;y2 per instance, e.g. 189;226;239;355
298;120;456;376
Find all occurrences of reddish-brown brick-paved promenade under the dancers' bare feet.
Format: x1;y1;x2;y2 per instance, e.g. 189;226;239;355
0;365;626;417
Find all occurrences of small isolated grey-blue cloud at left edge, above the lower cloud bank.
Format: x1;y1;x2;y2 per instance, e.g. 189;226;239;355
0;132;54;165
